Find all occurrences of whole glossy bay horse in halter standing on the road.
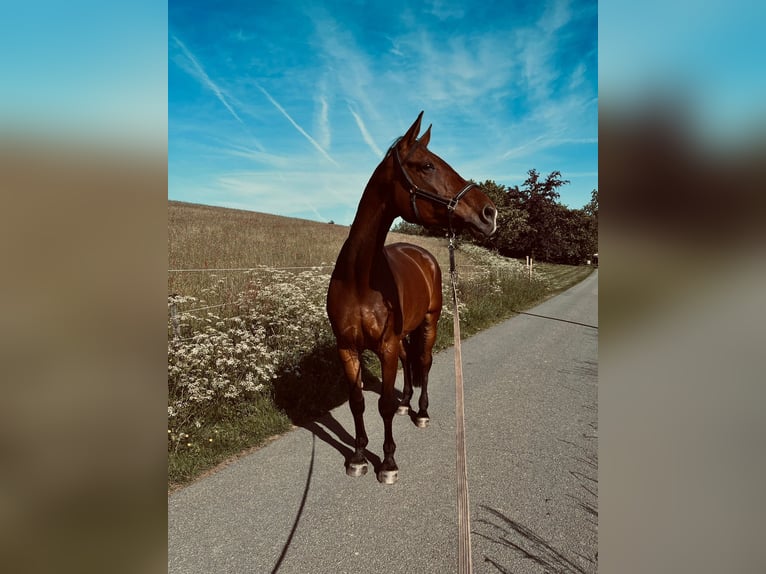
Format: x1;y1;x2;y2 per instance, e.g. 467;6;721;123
327;112;497;484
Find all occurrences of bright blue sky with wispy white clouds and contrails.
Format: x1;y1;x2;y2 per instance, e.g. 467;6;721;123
168;0;598;224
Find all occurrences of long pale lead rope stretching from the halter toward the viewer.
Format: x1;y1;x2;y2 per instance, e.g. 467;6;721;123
449;234;473;574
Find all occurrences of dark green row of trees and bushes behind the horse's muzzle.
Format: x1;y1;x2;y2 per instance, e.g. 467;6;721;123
393;169;598;265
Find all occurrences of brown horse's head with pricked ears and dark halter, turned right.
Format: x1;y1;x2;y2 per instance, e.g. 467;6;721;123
388;112;497;237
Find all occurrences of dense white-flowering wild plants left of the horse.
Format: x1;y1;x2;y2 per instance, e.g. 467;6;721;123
168;268;331;448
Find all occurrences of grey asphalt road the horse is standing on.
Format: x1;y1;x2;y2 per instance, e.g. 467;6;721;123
168;271;598;574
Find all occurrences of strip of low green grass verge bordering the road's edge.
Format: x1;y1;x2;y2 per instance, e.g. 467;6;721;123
168;265;592;490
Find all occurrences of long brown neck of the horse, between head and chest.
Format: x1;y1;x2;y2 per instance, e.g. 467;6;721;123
337;181;396;280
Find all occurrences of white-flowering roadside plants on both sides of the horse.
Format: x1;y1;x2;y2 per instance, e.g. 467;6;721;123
168;253;552;450
